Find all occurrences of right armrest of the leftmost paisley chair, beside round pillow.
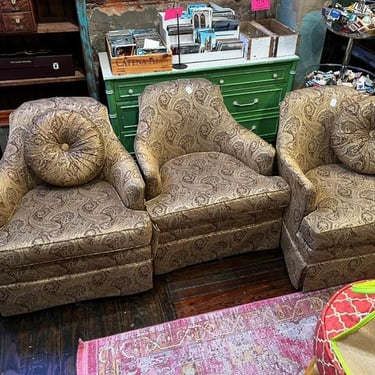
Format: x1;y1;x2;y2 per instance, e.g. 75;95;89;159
103;139;145;210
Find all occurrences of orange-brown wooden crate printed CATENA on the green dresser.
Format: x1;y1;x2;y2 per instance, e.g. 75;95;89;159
106;39;172;75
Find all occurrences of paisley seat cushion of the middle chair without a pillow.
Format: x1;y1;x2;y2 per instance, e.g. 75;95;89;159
146;152;289;241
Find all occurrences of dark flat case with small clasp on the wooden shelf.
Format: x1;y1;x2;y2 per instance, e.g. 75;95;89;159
0;55;74;80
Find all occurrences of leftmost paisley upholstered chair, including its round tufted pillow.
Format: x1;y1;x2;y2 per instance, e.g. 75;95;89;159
0;97;152;315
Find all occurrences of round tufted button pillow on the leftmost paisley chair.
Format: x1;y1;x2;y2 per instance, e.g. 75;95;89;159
24;110;105;186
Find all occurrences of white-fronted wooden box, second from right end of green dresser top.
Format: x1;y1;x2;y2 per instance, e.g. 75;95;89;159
240;21;274;60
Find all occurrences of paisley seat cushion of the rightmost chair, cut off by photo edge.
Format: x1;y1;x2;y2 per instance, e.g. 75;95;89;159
299;164;375;250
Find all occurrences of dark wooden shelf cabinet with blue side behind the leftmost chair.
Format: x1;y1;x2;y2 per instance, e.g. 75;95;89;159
0;0;99;125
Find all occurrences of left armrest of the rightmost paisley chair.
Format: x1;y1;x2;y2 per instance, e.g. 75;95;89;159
278;153;316;233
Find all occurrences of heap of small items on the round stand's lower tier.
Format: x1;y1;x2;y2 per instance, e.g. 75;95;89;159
305;67;375;95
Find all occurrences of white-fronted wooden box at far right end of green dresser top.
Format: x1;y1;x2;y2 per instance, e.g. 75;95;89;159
252;18;299;57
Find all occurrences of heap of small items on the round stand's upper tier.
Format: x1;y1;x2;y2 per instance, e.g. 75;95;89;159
322;1;375;37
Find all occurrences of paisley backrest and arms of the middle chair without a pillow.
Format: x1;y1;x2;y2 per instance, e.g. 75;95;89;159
134;78;275;199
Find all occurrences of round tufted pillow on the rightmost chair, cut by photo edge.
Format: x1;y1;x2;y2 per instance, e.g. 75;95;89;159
331;96;375;174
